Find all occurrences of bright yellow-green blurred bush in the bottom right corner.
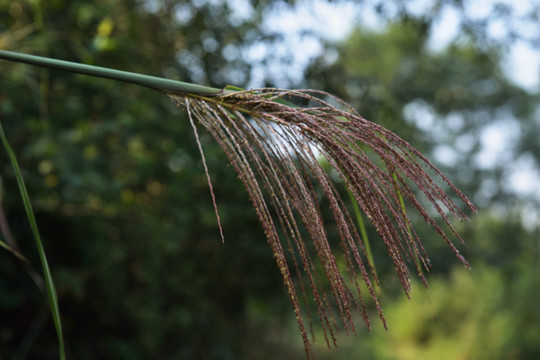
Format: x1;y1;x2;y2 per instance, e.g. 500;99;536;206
310;214;540;360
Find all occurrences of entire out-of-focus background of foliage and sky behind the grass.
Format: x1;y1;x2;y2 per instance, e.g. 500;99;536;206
0;0;540;360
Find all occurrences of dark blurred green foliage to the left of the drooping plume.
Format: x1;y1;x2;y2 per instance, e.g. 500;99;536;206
0;1;296;359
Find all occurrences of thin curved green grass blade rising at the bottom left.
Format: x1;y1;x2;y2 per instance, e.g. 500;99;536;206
0;122;66;360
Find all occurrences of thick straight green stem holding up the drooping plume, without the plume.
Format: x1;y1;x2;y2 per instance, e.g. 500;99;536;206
0;50;222;96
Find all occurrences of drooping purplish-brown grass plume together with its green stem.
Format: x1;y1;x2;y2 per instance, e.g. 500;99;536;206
0;51;476;358
